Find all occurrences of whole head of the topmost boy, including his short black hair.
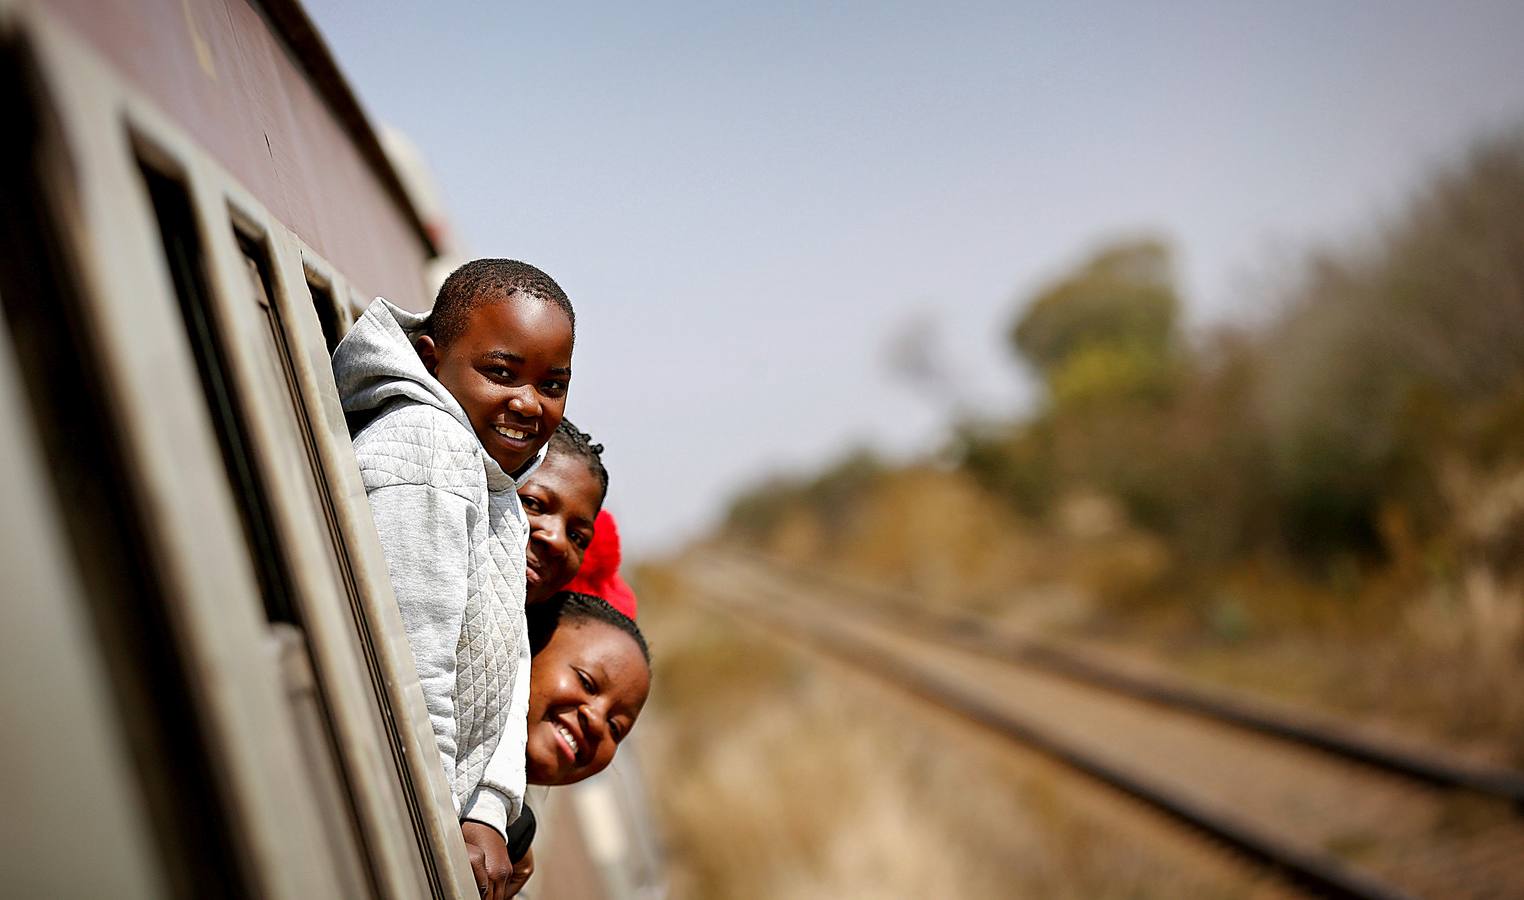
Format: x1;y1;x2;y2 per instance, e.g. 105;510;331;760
413;259;576;475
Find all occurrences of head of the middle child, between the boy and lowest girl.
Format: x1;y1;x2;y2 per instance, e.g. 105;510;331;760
518;419;608;606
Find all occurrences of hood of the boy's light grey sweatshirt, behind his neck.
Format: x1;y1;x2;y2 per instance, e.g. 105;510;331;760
334;297;546;490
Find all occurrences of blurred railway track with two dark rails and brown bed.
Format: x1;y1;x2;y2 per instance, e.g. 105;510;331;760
690;556;1524;898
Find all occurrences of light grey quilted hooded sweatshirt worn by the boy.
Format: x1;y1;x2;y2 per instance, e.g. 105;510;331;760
334;297;544;831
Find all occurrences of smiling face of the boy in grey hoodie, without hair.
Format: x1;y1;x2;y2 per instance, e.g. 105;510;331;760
418;295;572;475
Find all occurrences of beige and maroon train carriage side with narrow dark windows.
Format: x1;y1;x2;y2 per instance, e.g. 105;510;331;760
0;0;477;898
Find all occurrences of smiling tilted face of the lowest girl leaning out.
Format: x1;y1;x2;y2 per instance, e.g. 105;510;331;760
524;618;651;784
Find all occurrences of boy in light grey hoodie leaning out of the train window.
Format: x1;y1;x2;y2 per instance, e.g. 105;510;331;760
334;259;575;897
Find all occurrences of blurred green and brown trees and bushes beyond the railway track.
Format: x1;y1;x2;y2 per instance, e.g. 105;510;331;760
725;134;1524;758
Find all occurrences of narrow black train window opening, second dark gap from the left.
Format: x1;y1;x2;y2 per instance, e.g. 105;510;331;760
140;164;296;623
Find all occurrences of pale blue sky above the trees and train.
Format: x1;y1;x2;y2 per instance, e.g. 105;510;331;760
308;0;1524;554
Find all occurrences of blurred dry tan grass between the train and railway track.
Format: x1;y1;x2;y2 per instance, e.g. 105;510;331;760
640;570;1271;900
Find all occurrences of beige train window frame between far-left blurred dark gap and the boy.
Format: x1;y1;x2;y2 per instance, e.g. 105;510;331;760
6;12;477;898
